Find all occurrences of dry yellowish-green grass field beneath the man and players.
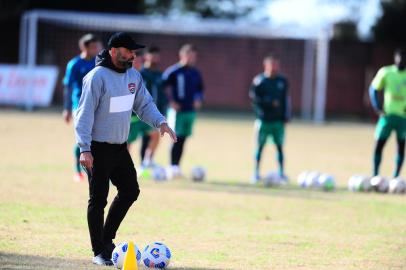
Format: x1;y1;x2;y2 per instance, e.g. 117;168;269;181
0;110;406;270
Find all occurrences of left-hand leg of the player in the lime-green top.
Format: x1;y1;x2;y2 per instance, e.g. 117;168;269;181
373;116;392;175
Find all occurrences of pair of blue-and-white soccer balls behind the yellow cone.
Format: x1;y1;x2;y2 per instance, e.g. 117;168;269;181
111;242;171;269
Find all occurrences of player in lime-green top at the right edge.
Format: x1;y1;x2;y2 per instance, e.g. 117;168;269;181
369;49;406;177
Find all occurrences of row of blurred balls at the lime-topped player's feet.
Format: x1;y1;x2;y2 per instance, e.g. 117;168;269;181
348;175;406;194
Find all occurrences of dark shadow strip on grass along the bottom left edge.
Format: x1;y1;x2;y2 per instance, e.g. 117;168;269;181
0;251;220;270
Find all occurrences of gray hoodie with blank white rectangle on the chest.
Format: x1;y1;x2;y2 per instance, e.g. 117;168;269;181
74;50;166;152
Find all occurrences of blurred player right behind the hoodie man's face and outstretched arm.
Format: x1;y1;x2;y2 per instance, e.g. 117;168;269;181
140;47;168;167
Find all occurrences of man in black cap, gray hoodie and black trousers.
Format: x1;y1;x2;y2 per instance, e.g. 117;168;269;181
74;32;177;265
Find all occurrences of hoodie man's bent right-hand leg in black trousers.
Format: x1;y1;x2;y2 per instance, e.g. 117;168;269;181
103;145;140;247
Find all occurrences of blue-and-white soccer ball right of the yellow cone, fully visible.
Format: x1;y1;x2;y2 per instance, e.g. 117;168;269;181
142;242;171;268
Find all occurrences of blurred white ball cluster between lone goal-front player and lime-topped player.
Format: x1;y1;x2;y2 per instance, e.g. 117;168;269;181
297;171;336;191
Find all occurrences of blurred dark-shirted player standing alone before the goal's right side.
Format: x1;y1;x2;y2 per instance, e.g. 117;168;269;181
249;55;290;183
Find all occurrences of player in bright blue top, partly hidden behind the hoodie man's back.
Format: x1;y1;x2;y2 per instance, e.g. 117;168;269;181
63;34;102;182
